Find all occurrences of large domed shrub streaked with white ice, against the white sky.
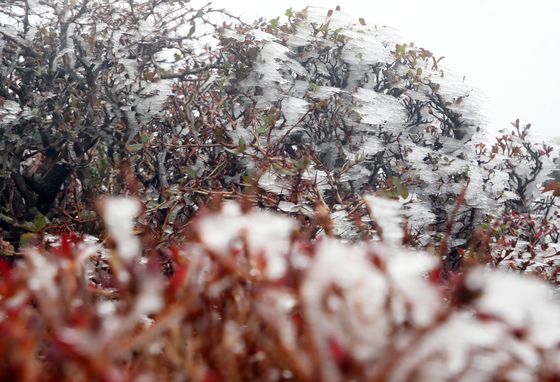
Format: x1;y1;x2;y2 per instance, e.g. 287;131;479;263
215;8;503;246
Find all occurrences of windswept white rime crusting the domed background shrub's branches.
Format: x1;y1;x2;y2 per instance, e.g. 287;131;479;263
218;7;508;242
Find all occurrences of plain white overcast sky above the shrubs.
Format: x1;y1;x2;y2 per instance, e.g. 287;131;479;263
202;0;560;138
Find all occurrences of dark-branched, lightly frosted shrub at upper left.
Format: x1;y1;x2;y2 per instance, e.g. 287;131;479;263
0;0;241;244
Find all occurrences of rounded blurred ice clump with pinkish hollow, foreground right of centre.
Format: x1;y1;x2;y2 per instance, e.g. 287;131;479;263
301;239;389;379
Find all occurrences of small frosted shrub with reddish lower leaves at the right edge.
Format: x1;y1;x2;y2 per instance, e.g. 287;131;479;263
468;120;560;284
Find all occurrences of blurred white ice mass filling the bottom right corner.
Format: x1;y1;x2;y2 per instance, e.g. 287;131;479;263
390;264;560;381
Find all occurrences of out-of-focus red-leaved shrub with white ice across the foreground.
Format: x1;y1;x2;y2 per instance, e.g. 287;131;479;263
0;196;560;381
